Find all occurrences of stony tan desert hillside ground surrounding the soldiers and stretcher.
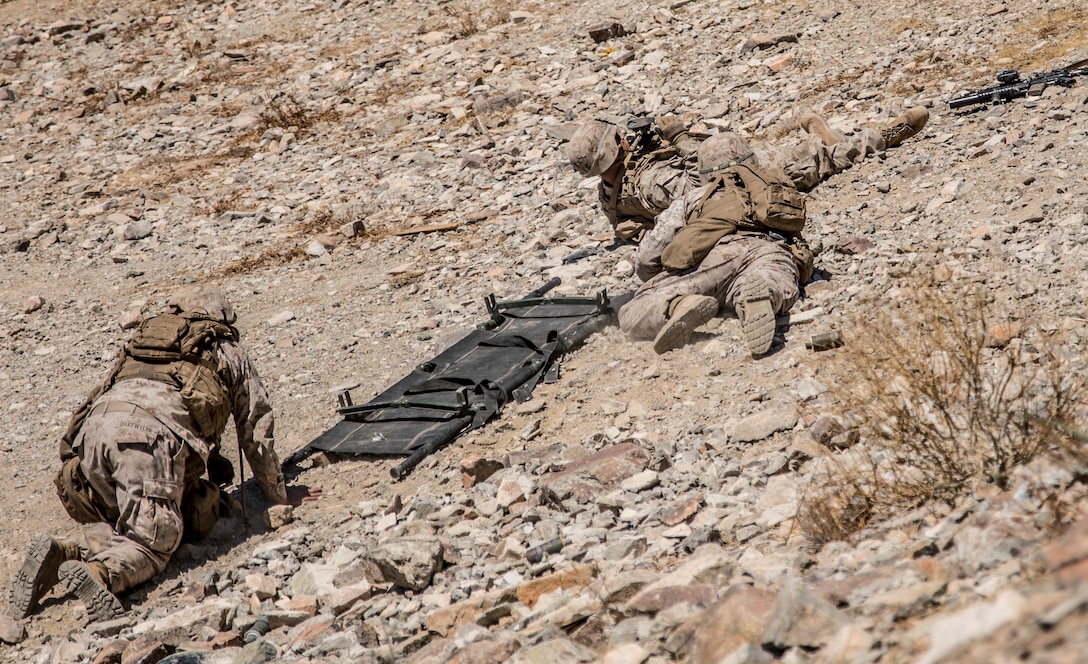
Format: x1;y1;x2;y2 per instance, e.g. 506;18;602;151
0;0;1088;664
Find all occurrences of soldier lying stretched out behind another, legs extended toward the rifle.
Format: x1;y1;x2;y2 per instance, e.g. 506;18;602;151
567;107;929;244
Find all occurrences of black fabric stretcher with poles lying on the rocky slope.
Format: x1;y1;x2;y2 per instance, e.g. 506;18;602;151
284;278;613;479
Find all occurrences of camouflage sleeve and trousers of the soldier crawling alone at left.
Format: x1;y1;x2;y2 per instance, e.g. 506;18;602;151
73;341;287;593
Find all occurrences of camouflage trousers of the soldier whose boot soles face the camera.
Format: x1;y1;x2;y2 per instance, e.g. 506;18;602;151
619;235;800;341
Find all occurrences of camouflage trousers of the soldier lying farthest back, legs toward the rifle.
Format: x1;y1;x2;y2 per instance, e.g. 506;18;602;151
750;127;885;192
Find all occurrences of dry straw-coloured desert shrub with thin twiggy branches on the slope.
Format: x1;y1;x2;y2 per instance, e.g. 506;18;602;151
799;284;1088;542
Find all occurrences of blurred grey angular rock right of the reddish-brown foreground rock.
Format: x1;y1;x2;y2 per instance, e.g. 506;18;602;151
761;578;850;650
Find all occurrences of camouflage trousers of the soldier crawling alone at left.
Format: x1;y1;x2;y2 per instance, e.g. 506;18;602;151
74;402;190;592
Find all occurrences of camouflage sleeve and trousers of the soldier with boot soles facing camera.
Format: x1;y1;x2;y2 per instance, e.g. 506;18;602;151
619;186;800;341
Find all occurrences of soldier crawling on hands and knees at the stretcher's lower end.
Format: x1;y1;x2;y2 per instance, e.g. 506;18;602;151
11;286;287;620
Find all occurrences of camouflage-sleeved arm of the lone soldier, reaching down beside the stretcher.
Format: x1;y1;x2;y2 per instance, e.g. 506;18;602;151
219;342;287;503
